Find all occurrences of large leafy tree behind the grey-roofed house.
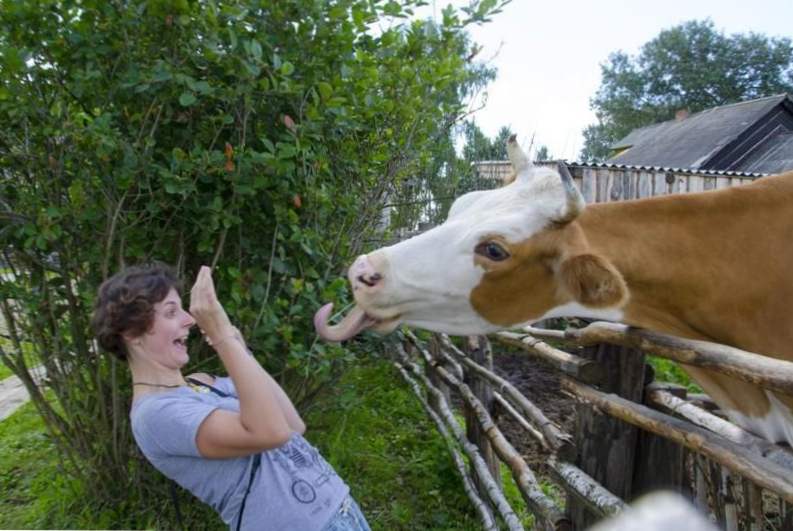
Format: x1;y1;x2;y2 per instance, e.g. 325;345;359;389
581;20;793;160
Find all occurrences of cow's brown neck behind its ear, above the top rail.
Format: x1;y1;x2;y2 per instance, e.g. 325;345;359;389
577;173;793;358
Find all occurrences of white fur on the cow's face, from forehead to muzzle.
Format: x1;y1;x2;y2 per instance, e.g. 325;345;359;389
355;164;580;334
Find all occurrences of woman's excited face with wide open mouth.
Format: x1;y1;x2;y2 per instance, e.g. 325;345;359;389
136;289;195;369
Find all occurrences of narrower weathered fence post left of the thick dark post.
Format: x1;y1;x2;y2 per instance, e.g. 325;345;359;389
463;336;501;486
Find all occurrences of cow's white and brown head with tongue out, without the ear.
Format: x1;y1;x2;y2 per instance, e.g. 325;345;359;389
315;139;624;340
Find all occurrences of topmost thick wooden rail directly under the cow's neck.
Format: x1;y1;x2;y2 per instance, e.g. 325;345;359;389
556;322;793;396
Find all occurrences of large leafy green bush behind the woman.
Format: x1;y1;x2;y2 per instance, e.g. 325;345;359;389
0;0;508;528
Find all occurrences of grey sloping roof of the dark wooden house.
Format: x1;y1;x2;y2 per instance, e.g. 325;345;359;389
606;94;789;169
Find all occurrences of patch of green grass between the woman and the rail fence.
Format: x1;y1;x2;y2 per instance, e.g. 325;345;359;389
306;361;481;530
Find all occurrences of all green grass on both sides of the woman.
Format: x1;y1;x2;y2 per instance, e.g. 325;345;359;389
0;360;544;531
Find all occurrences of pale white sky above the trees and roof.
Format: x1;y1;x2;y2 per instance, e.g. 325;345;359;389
431;0;793;161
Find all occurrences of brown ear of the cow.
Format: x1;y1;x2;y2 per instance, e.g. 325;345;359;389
558;254;628;308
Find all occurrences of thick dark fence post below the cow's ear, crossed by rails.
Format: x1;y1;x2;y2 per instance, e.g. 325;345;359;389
567;344;645;529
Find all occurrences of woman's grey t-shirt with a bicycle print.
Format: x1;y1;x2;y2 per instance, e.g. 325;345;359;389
130;378;349;531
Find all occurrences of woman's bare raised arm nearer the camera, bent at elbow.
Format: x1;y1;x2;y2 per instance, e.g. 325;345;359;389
190;266;292;458
